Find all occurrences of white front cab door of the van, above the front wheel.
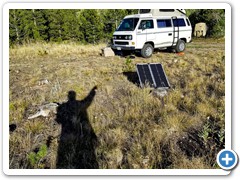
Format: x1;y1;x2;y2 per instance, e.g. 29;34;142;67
136;19;156;49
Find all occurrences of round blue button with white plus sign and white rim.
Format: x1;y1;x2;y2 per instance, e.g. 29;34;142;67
217;149;238;170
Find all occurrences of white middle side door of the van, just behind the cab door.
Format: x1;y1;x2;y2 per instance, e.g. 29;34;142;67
156;18;174;47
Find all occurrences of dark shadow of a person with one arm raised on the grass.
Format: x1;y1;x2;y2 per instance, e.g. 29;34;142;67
56;86;99;169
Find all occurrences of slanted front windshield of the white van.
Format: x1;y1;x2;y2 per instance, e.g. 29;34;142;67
116;18;139;31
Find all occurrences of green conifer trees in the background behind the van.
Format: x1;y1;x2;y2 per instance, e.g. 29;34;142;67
9;9;225;45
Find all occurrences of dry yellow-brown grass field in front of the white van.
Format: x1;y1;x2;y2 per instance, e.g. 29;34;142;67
9;39;225;169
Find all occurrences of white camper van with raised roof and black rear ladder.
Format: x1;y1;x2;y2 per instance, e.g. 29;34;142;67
112;9;192;58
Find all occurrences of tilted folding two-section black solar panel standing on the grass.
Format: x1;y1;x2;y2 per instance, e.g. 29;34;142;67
136;63;170;89
